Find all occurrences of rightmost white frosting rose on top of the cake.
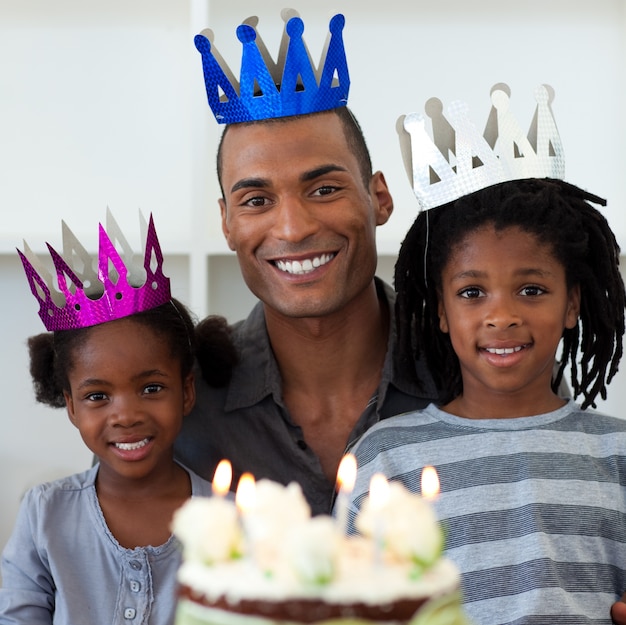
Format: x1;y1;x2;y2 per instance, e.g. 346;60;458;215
355;482;444;569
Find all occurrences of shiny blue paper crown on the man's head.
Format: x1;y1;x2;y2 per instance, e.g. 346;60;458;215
194;10;350;124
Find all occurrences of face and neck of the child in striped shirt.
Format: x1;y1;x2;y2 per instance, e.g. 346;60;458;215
439;225;580;418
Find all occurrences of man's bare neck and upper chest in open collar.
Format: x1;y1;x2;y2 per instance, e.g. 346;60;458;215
266;283;389;481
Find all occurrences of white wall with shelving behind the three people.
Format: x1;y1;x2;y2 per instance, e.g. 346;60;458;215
0;0;626;546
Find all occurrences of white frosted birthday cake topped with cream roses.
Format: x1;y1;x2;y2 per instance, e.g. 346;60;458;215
173;480;467;625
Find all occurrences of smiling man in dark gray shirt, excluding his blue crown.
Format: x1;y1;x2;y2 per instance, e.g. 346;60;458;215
176;107;435;514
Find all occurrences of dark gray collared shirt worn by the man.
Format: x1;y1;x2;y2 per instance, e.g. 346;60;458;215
175;279;436;514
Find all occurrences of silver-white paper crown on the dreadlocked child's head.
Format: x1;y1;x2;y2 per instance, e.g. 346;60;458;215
398;83;565;210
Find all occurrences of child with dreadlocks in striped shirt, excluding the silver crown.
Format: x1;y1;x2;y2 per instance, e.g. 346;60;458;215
344;179;626;625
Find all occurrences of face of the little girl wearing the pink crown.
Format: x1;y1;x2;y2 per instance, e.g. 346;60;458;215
65;319;195;480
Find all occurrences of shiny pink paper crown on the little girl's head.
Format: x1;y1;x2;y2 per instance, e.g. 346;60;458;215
17;211;171;331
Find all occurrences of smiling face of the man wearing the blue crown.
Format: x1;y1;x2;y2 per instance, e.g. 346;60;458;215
214;113;392;318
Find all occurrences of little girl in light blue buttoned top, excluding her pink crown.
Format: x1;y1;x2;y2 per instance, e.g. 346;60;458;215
0;216;234;625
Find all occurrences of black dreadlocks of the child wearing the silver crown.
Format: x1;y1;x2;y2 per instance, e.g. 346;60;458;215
394;178;626;408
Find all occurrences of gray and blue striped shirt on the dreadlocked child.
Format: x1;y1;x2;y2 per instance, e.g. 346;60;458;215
350;401;626;625
